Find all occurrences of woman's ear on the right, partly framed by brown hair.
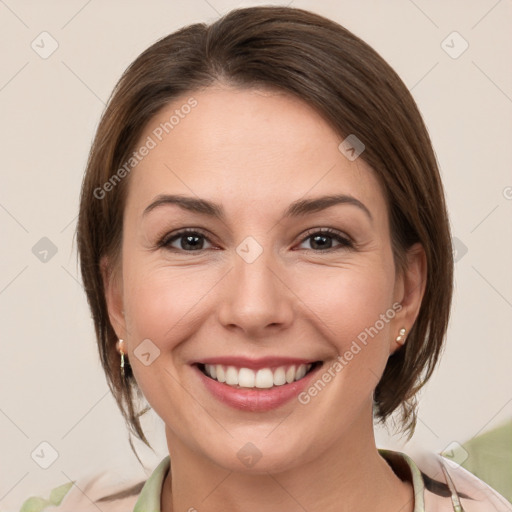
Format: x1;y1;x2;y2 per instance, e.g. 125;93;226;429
389;243;427;354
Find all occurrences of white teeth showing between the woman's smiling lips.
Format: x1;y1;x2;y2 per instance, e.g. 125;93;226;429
197;361;322;389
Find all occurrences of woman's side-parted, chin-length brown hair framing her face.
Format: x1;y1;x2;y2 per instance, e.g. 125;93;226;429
77;7;453;460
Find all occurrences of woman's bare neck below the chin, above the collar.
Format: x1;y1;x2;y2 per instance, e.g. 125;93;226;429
161;410;414;512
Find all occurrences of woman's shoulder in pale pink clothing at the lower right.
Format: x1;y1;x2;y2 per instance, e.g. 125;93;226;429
415;453;512;512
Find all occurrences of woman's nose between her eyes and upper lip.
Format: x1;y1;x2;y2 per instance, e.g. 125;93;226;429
217;245;297;339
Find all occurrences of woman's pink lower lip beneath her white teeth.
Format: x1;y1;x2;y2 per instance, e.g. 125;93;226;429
193;365;321;412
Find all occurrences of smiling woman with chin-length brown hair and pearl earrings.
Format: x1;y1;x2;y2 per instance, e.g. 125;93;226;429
19;7;506;512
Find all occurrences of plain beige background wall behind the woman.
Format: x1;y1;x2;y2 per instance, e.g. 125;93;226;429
0;0;512;511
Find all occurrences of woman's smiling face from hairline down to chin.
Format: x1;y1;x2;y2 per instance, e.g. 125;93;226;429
103;87;420;472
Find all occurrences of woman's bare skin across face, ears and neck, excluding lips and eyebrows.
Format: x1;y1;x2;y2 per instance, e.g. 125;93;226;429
103;84;426;512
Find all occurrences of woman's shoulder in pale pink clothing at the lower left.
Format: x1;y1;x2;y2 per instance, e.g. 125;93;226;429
20;472;145;512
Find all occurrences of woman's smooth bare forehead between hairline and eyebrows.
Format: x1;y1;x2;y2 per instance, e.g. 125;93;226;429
127;86;385;225
